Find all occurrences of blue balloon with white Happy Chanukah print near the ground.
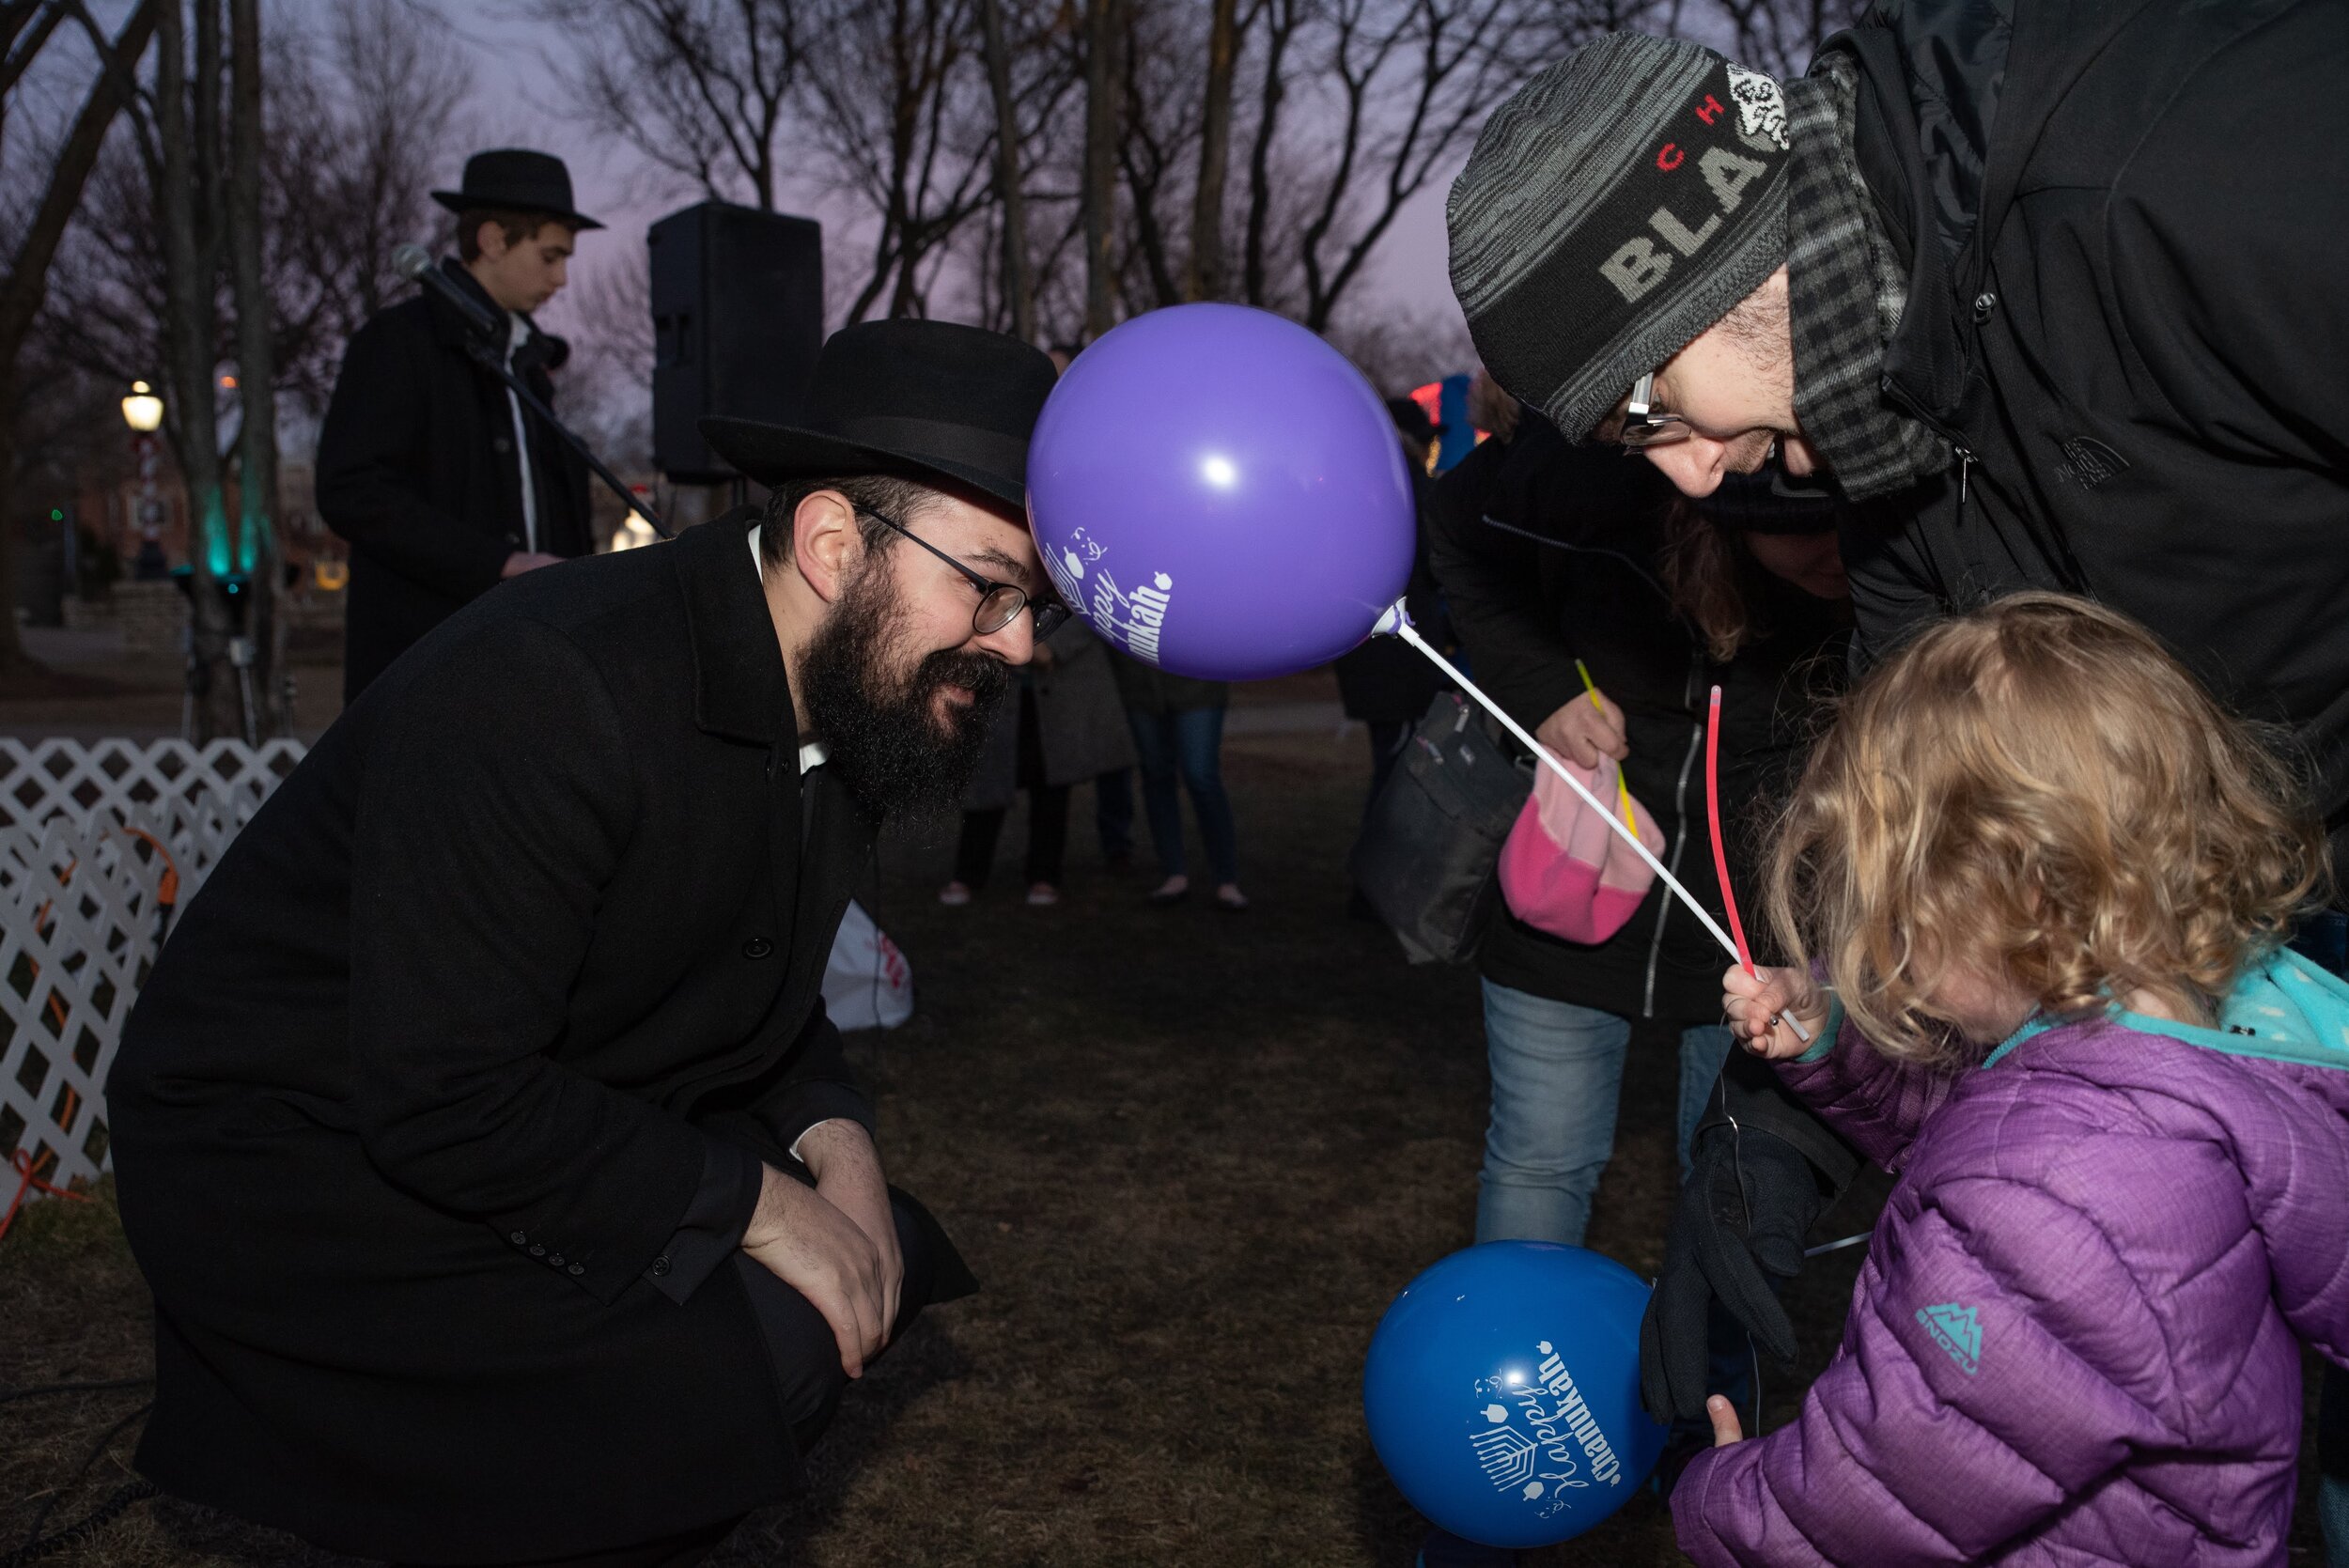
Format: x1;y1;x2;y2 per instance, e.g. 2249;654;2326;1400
1362;1242;1666;1547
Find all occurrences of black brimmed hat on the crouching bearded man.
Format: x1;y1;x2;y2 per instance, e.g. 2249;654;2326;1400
700;319;1055;507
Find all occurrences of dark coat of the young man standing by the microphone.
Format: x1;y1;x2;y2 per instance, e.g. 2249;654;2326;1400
318;263;595;702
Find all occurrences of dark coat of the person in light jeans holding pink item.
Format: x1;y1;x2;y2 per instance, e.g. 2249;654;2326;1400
1431;411;1846;1026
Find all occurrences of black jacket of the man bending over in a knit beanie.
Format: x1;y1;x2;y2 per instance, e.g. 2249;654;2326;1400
1826;0;2349;862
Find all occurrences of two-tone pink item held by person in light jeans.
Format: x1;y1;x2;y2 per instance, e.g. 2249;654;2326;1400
1501;758;1663;943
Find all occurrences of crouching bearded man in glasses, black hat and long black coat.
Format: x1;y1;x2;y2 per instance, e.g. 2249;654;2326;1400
108;321;1060;1568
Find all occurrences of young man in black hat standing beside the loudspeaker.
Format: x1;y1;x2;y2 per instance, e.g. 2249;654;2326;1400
318;147;604;702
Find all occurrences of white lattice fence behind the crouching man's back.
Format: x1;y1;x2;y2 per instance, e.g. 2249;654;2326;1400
0;739;303;1206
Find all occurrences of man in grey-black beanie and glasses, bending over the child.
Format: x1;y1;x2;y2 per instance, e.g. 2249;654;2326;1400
1447;18;2349;1563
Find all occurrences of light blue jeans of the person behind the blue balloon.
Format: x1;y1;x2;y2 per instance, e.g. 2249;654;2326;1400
1475;981;1729;1247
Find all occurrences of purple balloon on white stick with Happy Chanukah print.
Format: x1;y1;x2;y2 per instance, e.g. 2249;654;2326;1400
1027;305;1417;681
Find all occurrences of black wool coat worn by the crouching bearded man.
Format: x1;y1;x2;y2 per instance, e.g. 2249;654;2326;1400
108;512;874;1561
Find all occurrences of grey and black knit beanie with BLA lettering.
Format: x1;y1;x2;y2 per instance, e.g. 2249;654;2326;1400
1445;33;1788;442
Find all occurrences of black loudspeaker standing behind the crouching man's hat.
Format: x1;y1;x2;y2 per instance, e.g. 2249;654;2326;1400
648;202;825;484
